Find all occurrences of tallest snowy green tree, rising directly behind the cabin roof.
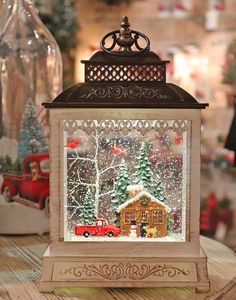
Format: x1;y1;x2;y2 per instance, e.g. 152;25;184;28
135;142;152;191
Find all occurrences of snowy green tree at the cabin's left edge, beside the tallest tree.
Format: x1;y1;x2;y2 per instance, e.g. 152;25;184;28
112;160;130;225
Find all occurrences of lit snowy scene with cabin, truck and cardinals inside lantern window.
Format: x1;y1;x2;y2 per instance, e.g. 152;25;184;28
63;120;189;241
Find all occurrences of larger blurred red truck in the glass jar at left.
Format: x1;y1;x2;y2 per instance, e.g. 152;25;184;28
1;154;49;215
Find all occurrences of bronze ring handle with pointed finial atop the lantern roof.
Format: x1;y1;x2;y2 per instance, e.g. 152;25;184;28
100;17;150;56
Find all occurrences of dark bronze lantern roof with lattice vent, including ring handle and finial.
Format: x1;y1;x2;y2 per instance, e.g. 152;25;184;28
44;17;208;109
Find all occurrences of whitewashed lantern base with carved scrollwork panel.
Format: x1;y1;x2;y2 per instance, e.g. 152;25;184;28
39;246;210;292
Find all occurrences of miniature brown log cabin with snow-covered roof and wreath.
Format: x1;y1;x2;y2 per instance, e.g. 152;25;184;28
117;185;170;238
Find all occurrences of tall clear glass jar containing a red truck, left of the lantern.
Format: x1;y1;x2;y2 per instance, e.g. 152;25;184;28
0;0;62;233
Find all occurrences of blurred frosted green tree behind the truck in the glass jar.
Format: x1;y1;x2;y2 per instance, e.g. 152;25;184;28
18;99;48;162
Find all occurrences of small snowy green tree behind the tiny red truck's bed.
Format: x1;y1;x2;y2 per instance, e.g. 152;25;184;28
79;189;96;225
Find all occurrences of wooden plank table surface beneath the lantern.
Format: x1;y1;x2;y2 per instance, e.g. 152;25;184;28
0;235;236;300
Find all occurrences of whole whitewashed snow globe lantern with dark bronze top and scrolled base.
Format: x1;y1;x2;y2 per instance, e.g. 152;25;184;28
40;17;209;292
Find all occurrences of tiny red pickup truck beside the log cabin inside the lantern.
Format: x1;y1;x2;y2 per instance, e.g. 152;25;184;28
75;218;120;237
